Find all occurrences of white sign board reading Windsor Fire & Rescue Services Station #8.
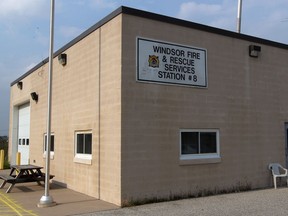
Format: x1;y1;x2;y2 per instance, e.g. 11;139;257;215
137;38;207;87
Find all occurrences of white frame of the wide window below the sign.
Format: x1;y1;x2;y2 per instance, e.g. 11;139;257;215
179;129;221;163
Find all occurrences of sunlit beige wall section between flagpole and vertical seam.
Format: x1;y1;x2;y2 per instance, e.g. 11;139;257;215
47;31;99;197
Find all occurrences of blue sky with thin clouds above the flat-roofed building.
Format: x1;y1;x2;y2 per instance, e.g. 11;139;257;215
0;0;288;135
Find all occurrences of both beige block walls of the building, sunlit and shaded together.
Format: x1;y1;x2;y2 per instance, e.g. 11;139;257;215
9;10;288;205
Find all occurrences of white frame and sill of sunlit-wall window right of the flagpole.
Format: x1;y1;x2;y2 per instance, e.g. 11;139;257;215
74;130;93;164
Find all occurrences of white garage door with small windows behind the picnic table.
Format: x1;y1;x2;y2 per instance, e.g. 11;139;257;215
18;103;30;164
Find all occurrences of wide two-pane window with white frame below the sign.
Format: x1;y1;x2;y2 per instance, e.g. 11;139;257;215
180;129;220;160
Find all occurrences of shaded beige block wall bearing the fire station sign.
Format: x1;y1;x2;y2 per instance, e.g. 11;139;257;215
122;15;288;201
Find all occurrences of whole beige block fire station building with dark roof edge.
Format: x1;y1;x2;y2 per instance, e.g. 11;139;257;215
9;7;288;206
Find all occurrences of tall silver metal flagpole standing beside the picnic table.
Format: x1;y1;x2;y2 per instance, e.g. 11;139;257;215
38;0;56;207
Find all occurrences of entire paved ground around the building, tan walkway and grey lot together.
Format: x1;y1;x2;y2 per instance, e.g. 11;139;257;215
0;165;288;216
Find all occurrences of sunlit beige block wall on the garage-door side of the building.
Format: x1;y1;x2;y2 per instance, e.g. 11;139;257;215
10;16;121;205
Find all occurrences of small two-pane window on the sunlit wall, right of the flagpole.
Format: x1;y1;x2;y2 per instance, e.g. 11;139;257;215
75;131;92;160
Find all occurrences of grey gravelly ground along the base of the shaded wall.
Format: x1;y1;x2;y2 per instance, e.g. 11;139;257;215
75;188;288;216
